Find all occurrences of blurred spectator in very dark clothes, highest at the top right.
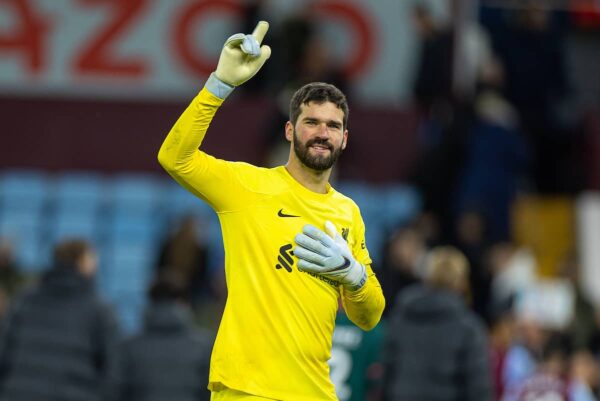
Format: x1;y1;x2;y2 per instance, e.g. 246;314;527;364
483;1;573;192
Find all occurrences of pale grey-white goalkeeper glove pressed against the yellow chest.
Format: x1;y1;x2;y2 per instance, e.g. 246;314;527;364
294;221;367;290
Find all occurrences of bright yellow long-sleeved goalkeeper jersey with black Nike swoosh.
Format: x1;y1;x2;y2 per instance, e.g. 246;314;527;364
159;89;384;401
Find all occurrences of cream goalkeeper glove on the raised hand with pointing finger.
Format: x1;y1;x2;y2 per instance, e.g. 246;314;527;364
214;21;271;87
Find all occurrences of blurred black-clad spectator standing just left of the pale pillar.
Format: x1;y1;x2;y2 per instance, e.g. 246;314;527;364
412;5;471;242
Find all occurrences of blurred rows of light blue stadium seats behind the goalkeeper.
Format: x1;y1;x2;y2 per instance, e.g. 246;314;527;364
0;169;420;332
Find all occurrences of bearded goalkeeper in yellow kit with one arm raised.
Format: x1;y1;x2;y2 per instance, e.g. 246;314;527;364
158;21;385;401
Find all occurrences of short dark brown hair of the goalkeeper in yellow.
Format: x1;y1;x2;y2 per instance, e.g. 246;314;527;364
290;82;350;129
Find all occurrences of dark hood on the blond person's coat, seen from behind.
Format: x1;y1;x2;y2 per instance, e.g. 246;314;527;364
398;285;465;320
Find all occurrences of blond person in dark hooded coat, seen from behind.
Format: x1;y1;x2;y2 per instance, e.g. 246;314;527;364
384;247;493;401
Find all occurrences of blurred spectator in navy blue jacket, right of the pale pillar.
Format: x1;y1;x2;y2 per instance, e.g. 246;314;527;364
455;55;530;241
